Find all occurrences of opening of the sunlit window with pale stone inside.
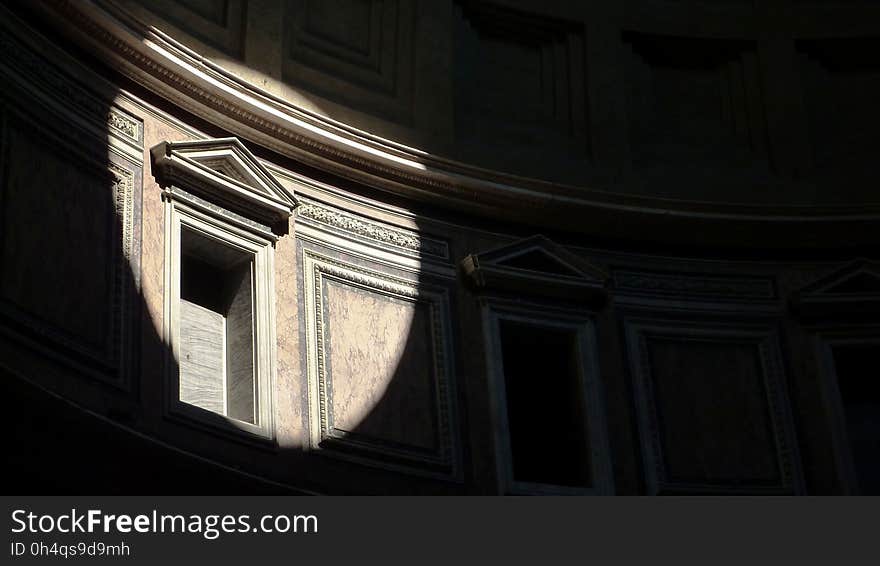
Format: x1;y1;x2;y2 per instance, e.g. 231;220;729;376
179;228;259;424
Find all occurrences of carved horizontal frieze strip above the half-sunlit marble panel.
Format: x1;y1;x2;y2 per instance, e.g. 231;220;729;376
296;201;449;259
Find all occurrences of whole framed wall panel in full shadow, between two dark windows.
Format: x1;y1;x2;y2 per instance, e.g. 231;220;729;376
625;320;801;493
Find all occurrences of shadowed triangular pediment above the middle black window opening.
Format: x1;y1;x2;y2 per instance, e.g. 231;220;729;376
462;235;608;306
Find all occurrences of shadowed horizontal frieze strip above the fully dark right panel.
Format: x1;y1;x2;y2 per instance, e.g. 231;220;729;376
613;269;776;300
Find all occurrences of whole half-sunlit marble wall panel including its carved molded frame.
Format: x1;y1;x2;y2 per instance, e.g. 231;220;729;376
302;249;459;478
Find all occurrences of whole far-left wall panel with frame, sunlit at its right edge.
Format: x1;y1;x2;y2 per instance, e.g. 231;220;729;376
0;106;140;385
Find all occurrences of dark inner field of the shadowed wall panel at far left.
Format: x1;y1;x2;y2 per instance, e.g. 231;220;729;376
0;118;118;355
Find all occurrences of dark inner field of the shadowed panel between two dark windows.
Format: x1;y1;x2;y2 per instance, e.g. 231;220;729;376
646;336;783;489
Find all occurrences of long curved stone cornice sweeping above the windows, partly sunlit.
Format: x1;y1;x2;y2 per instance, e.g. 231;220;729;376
22;0;880;248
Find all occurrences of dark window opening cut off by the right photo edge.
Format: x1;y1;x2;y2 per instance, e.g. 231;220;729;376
832;343;880;495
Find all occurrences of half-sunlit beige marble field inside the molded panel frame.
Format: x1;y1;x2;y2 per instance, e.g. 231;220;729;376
325;282;436;449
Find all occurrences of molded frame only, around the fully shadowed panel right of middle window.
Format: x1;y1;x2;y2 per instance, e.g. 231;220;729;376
624;318;803;494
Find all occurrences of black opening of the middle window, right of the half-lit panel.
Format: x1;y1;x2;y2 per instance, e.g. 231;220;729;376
500;320;592;487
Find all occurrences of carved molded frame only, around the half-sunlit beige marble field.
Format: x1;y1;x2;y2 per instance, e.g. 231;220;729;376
302;249;460;479
